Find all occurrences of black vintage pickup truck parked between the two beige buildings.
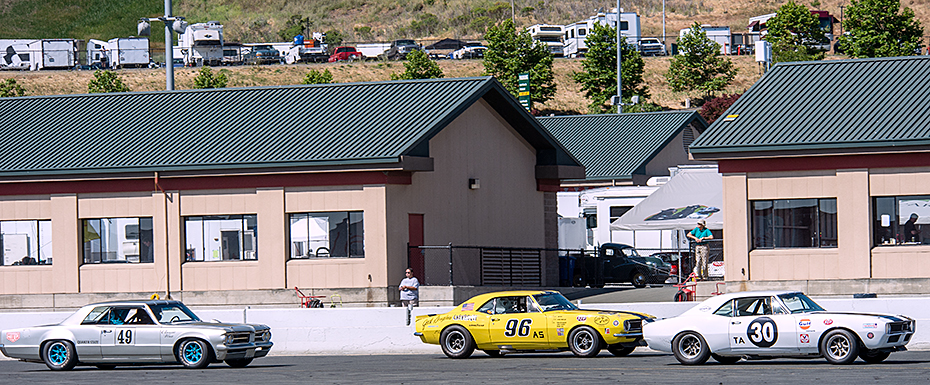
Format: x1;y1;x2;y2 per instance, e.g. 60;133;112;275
572;243;671;287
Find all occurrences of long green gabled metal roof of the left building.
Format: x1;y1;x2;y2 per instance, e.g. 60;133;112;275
0;77;579;176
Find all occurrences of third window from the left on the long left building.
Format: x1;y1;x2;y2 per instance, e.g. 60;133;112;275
184;214;258;262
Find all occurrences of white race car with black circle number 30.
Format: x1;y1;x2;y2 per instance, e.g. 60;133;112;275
643;291;916;365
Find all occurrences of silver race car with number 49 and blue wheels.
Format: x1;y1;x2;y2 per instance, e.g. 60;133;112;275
0;300;273;370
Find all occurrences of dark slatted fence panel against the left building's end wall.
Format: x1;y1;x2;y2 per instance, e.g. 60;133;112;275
481;248;542;286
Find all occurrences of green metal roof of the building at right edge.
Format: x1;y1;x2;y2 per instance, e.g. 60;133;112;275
691;56;930;158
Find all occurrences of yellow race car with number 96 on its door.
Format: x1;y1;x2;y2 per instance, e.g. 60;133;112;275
414;291;655;358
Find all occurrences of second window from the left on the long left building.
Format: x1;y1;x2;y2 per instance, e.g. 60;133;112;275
82;218;154;263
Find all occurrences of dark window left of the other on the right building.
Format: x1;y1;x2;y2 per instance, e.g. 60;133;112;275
750;198;837;249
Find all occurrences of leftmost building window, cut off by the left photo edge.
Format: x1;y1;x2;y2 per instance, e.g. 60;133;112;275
0;220;52;266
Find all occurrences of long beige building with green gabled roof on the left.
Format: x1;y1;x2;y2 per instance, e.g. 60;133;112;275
0;78;584;308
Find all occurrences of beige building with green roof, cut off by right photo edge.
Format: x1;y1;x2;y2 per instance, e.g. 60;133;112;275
691;57;930;296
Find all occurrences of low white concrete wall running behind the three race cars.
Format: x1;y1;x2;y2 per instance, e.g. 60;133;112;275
0;298;930;355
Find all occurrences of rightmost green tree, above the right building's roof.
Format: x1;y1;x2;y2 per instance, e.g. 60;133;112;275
839;0;924;58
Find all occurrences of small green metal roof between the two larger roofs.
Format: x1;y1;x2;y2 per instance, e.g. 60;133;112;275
537;111;707;180
